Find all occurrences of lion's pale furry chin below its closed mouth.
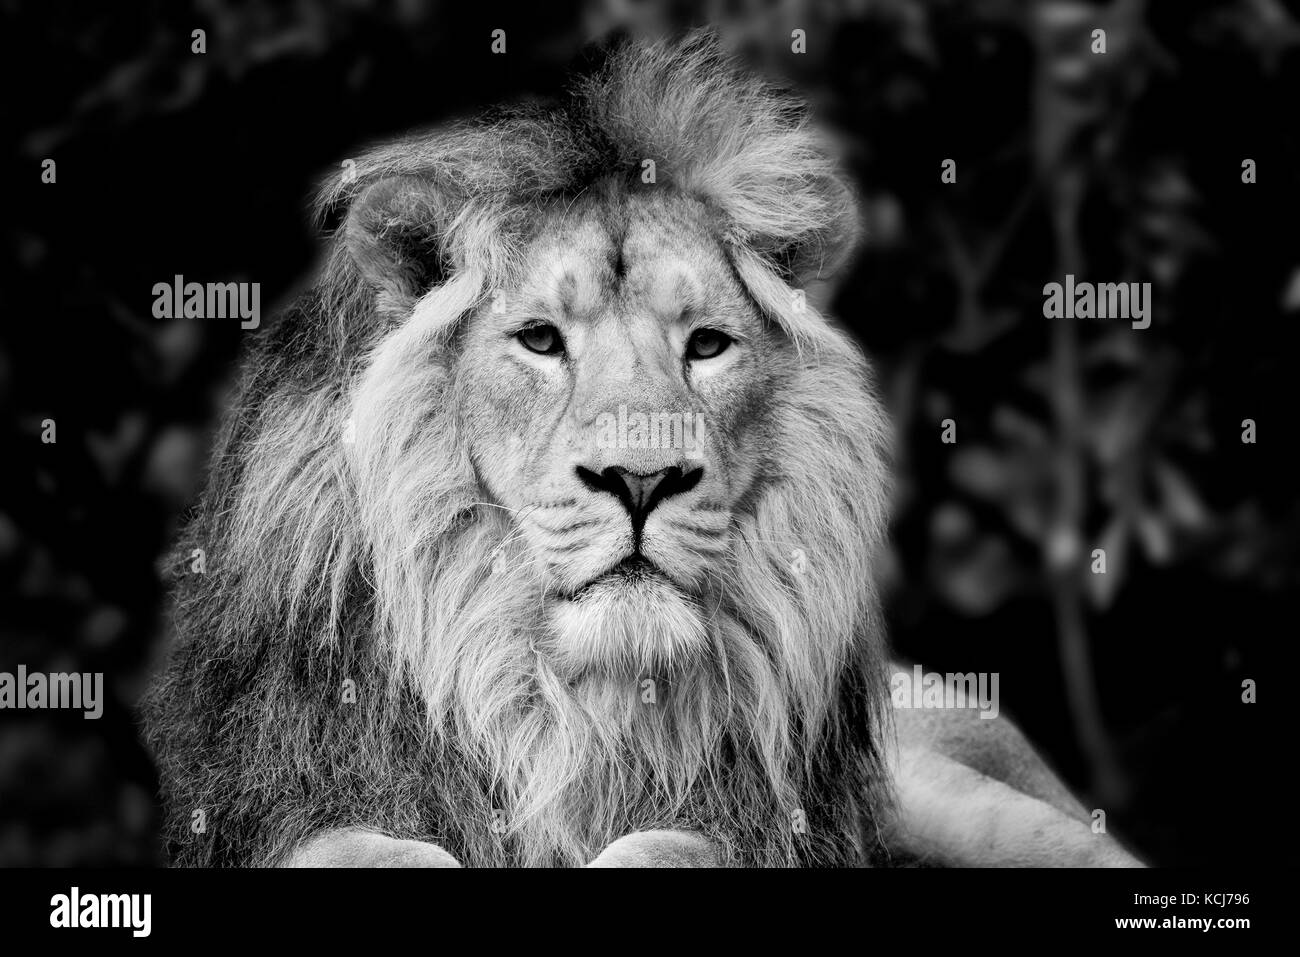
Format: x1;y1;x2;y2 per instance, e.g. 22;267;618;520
540;566;709;680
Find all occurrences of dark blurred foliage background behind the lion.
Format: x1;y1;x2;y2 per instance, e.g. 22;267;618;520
0;0;1300;865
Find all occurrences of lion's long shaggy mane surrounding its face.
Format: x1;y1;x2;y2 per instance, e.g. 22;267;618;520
146;35;889;865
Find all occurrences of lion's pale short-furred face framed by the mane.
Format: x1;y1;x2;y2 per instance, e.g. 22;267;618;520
455;195;784;676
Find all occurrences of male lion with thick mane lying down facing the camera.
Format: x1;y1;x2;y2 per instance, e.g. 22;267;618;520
144;33;1135;866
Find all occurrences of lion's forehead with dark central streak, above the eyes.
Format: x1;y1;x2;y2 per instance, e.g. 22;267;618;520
519;196;738;321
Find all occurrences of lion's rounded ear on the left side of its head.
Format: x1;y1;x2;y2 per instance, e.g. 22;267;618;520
343;176;447;303
